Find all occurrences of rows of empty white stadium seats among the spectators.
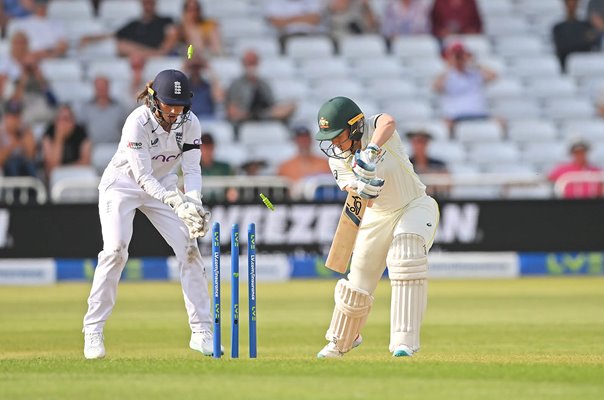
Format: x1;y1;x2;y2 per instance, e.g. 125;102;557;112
5;0;604;203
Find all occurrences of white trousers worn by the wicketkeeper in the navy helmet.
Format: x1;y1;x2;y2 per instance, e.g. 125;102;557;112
84;176;211;333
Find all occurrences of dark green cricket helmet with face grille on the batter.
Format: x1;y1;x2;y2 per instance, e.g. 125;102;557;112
315;96;365;158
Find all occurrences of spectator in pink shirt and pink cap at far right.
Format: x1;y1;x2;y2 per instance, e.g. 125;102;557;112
548;139;604;199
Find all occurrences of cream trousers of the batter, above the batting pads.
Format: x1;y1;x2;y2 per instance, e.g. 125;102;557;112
348;196;439;294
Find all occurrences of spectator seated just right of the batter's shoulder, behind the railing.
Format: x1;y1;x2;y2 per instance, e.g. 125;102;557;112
406;130;449;196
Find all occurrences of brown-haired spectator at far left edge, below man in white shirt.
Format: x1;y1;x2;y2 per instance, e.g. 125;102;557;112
0;31;56;125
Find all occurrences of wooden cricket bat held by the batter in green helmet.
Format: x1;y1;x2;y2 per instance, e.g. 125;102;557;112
325;191;367;274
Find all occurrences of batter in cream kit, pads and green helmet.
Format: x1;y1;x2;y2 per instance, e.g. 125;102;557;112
315;97;439;358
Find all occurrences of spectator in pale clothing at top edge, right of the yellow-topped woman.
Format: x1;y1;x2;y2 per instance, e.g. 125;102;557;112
264;0;325;50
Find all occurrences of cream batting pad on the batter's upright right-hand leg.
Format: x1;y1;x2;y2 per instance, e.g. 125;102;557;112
386;233;428;351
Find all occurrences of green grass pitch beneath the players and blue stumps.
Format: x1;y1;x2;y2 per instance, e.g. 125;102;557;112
0;278;604;400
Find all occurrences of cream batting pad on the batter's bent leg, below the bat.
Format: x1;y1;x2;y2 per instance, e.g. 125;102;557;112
325;279;373;353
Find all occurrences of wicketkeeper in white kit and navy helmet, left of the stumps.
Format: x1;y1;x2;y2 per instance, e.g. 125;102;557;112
83;70;219;359
